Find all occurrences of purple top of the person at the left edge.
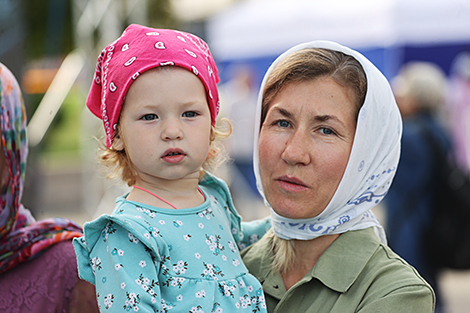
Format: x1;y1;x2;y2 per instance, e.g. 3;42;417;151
0;240;98;313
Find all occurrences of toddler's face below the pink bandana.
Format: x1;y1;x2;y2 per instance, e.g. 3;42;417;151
113;67;211;185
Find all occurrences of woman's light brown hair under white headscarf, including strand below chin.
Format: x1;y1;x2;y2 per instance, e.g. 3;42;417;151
260;48;367;272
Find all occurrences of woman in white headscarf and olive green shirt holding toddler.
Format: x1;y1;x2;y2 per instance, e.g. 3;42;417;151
243;41;435;313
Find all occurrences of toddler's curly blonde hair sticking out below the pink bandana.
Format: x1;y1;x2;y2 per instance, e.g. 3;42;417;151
98;118;232;186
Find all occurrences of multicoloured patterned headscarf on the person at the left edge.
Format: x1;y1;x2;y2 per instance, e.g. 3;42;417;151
0;63;82;273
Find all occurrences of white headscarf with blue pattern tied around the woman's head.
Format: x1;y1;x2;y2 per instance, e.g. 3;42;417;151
253;41;402;243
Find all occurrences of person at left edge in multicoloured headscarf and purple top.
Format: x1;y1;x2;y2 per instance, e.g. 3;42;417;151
0;63;98;312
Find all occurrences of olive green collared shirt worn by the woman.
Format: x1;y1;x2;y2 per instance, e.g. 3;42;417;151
242;228;435;313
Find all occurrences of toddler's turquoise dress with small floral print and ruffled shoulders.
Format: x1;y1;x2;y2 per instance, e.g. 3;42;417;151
74;174;271;313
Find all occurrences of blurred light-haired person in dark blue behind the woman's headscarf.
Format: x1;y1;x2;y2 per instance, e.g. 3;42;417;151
385;62;450;312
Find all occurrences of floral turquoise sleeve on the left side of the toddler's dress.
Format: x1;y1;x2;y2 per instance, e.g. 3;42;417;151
90;221;161;313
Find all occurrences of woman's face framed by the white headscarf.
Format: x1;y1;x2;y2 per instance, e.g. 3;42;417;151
258;77;356;219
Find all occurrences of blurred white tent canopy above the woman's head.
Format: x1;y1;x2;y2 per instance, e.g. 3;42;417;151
207;0;470;61
